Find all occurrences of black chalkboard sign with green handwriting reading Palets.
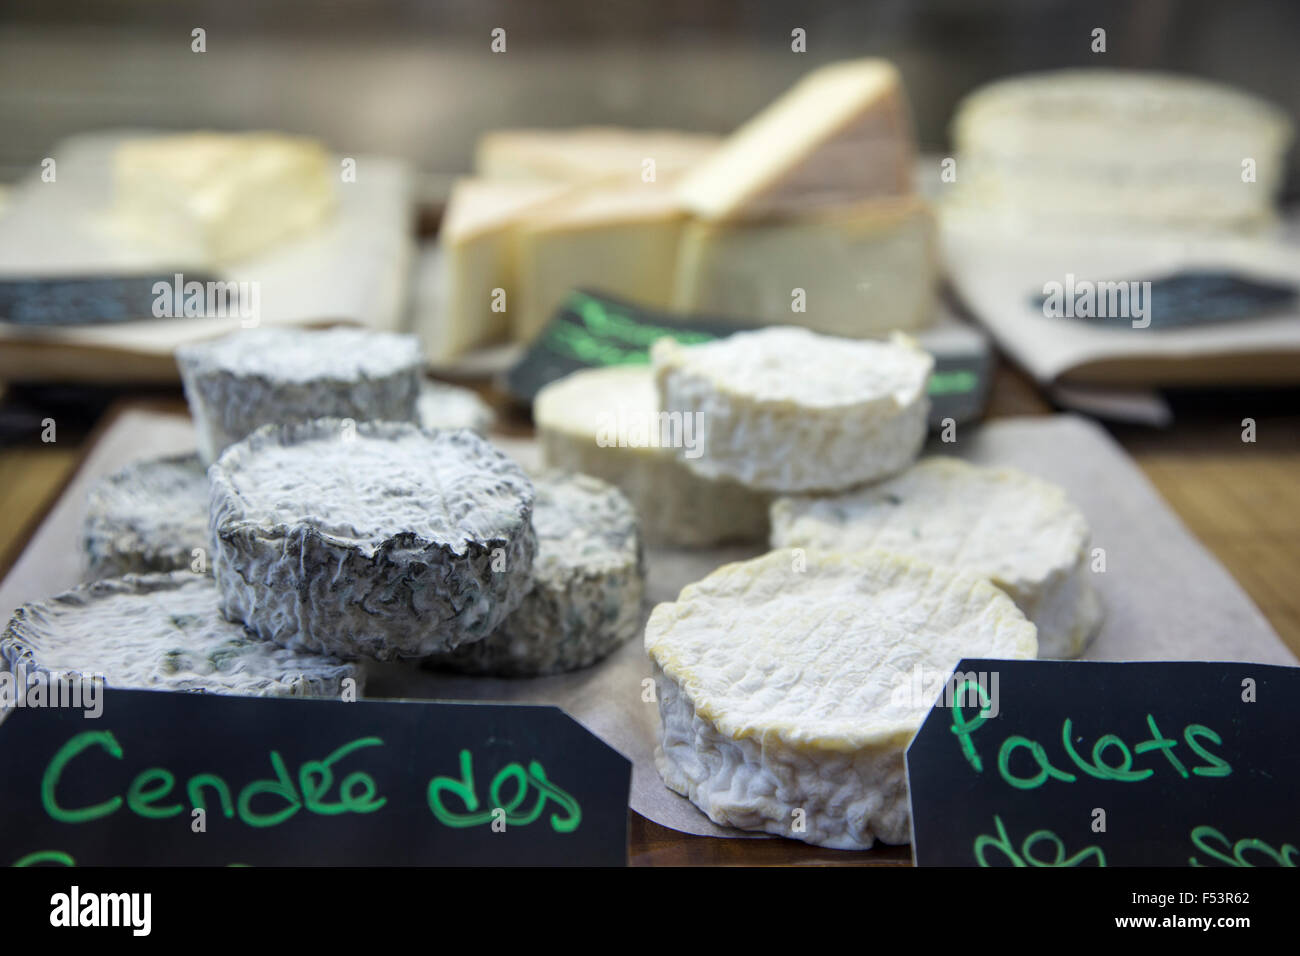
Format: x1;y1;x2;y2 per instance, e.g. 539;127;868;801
907;661;1300;866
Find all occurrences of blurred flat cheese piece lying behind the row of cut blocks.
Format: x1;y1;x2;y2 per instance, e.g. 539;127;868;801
475;126;722;183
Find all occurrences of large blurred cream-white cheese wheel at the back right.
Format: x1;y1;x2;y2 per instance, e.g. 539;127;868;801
945;68;1295;231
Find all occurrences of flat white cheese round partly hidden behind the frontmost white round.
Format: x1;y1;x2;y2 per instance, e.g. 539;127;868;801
772;458;1102;658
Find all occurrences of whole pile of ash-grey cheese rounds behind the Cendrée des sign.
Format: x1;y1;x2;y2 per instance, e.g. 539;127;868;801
17;323;647;693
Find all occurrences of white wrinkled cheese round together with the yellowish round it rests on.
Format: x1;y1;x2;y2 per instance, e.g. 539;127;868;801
533;326;933;546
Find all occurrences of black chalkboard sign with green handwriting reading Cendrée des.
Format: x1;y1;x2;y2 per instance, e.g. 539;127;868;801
0;689;632;866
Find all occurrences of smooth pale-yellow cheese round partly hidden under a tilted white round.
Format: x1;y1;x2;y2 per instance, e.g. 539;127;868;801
533;365;770;548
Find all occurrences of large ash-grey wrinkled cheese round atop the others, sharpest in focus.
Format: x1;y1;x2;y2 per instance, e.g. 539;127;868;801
211;419;537;661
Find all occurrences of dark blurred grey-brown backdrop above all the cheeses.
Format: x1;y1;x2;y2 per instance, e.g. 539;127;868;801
0;0;1300;198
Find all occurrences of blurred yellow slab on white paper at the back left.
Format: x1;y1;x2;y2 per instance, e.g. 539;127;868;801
113;133;337;264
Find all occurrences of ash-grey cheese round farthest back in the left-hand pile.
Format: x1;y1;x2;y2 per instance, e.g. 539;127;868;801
176;328;424;464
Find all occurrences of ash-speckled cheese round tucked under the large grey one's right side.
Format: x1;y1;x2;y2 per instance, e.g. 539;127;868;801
437;471;645;678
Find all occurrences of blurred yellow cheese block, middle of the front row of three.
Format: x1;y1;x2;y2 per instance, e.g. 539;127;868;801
510;182;685;342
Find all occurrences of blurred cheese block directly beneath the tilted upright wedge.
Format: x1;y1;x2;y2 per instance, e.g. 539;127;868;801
673;196;939;338
